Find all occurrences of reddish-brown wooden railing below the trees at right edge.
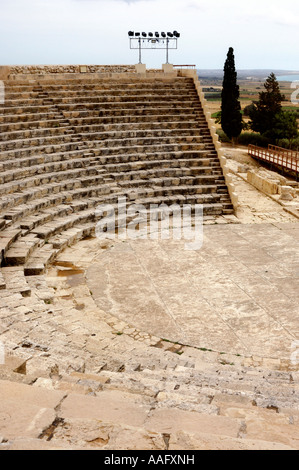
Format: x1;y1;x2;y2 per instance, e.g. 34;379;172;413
248;145;299;176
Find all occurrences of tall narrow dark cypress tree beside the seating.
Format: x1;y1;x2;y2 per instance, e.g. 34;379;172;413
221;47;243;144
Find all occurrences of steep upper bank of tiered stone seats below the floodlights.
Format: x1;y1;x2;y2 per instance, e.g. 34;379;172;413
0;79;232;292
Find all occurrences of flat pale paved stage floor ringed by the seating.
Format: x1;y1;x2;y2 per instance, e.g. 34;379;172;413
86;223;299;359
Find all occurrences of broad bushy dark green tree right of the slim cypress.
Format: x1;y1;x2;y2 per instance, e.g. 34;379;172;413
249;73;285;135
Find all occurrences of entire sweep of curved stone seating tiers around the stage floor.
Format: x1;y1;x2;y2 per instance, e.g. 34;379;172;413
0;75;276;450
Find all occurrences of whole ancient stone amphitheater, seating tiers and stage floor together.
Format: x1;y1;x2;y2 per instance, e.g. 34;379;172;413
0;66;299;450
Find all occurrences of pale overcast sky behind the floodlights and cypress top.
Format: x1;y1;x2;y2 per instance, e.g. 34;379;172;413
0;0;299;70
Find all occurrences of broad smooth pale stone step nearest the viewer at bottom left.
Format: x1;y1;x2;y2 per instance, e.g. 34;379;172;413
0;381;276;449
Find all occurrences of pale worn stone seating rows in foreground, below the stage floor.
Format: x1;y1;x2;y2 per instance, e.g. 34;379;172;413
0;268;299;450
